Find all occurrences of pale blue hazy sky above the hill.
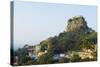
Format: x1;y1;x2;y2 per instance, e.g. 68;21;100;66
14;1;97;47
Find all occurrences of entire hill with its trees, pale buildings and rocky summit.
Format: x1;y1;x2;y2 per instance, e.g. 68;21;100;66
12;16;97;65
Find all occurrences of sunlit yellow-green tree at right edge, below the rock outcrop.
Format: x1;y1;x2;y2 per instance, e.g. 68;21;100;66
80;32;97;49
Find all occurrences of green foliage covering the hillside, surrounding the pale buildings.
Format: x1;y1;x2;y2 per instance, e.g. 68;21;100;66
14;27;97;65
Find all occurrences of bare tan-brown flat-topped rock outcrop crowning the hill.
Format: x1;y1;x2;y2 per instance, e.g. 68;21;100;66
66;16;89;32
